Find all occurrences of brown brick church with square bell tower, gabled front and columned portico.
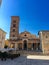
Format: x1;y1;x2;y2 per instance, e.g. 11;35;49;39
10;16;49;52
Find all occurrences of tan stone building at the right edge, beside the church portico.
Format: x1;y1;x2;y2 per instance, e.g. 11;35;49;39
39;30;49;53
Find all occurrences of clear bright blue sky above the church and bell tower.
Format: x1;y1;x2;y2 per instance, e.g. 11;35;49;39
0;0;49;38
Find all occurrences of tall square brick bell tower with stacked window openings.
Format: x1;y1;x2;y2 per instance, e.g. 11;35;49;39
10;16;19;48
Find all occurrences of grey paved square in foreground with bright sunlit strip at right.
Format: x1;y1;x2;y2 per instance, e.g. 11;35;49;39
0;55;49;65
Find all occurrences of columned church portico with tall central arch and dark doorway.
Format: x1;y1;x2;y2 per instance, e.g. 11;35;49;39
18;39;40;51
